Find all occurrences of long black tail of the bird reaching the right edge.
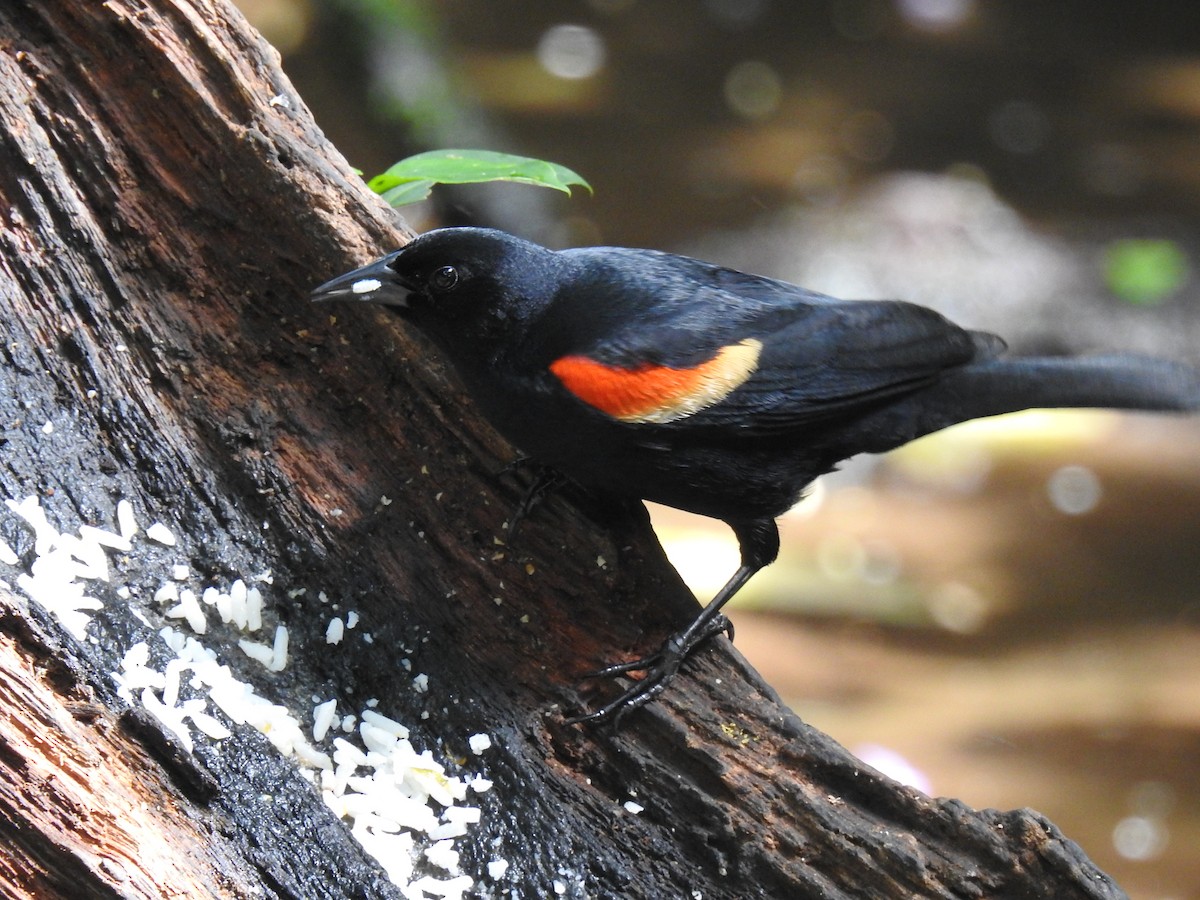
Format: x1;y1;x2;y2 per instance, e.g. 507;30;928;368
865;356;1200;452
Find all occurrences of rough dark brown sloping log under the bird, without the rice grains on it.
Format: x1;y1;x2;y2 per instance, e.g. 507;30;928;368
0;0;1122;898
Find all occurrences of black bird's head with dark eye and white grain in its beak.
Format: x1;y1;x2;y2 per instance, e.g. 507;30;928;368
312;228;560;356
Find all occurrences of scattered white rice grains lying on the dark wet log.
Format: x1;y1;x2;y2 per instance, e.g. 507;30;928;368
0;497;496;898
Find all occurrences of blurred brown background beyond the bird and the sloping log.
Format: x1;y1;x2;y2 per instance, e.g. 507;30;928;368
240;0;1200;899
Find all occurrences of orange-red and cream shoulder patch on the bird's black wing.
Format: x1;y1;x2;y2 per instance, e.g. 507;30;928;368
550;338;762;424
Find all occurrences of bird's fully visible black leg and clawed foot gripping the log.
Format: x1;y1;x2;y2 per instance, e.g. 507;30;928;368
566;518;779;725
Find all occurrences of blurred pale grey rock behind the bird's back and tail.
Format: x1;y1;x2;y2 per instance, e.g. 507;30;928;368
683;173;1200;364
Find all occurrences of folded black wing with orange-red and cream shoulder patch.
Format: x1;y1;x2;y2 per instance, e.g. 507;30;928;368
540;257;1003;434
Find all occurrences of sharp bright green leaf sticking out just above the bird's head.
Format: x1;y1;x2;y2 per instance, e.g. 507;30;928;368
367;150;592;206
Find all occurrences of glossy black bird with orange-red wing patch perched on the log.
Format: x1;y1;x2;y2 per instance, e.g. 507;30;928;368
313;228;1200;721
